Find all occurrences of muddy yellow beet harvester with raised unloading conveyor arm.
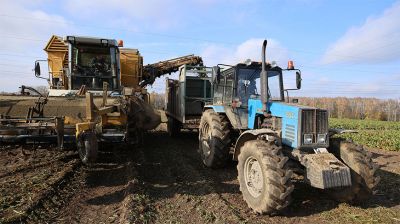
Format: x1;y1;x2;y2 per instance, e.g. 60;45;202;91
0;36;202;163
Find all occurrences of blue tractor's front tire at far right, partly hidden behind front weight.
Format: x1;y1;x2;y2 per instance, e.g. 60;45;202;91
329;138;380;202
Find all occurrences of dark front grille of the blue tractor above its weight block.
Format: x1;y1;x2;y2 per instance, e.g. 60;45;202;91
301;109;328;143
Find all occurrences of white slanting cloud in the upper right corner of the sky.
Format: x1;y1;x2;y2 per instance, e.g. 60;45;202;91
322;2;400;64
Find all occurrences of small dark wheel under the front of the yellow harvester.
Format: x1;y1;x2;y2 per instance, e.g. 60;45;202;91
77;131;98;164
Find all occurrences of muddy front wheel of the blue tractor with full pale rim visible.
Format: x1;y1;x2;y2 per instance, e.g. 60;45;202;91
237;140;294;214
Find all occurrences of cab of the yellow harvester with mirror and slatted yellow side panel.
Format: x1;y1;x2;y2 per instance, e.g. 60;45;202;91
35;36;121;96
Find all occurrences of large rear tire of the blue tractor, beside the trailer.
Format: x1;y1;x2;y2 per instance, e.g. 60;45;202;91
199;110;231;168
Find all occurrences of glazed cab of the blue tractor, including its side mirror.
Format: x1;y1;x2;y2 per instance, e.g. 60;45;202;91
209;62;301;130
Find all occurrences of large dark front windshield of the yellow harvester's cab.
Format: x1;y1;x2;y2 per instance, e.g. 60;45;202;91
71;45;117;90
